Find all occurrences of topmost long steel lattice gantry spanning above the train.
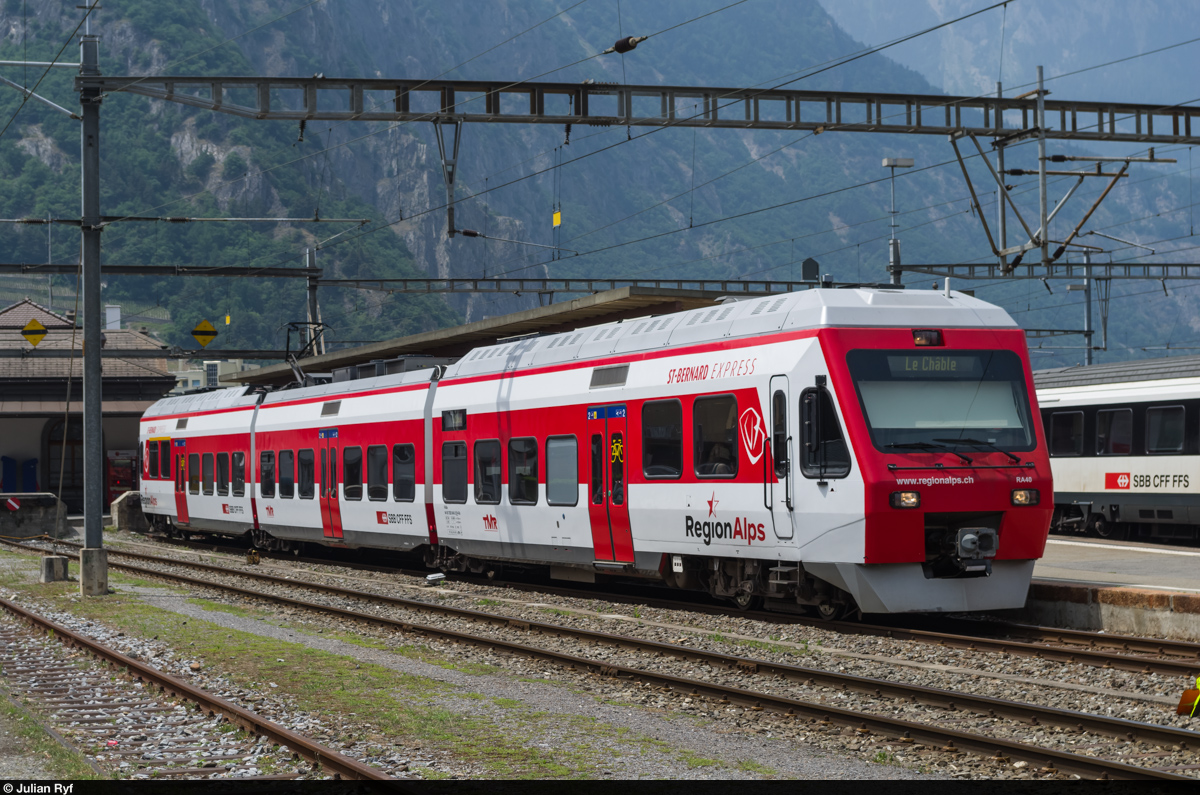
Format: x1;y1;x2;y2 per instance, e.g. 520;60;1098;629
76;74;1200;144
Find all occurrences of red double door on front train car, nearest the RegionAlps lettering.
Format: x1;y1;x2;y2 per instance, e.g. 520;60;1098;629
588;404;634;563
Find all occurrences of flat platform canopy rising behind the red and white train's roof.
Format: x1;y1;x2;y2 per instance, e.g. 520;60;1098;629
221;286;725;384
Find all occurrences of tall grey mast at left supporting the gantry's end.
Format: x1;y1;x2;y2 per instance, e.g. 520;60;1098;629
79;35;108;596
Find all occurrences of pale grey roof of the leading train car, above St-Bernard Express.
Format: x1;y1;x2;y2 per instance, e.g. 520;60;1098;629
445;288;1016;378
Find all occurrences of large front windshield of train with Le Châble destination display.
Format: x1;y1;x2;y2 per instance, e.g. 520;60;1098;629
846;351;1037;453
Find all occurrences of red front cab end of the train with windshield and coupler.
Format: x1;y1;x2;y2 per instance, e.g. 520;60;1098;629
802;329;1054;612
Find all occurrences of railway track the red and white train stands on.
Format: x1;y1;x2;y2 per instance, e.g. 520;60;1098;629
96;539;1200;679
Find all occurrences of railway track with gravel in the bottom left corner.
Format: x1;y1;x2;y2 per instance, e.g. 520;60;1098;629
0;599;390;781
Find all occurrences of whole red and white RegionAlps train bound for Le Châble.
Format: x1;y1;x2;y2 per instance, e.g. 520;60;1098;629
140;289;1054;617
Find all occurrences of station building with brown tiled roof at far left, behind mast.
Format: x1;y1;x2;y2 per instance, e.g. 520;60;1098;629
0;298;175;510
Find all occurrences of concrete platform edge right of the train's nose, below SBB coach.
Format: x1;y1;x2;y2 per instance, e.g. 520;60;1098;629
1004;537;1200;641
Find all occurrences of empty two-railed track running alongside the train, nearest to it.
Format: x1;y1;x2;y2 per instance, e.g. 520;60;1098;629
4;544;1200;781
